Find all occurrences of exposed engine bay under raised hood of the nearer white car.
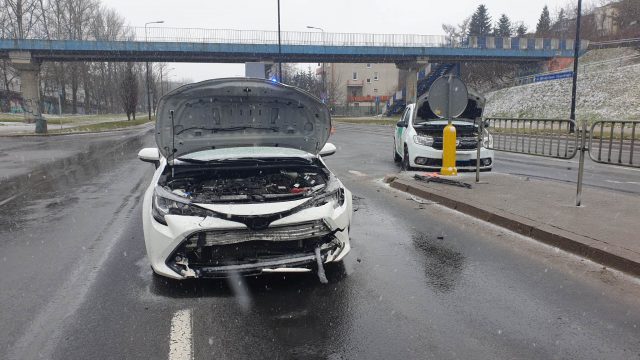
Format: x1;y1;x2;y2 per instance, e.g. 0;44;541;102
159;160;330;203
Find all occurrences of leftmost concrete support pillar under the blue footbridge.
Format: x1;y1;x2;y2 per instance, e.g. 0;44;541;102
9;51;42;132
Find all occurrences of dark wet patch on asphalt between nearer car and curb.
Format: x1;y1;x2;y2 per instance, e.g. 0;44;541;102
412;234;466;293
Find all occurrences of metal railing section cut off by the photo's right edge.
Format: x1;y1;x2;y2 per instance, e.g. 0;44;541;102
588;121;640;168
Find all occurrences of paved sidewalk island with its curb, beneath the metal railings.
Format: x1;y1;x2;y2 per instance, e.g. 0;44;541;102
391;172;640;275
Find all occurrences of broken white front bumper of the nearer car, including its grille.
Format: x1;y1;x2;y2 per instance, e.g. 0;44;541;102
143;184;352;279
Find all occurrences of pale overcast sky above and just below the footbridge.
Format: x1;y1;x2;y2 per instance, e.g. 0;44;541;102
103;0;590;81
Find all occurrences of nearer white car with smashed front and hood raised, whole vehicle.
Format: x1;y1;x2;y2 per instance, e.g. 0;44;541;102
138;78;352;281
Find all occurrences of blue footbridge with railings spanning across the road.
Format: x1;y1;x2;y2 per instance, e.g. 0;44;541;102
0;27;587;125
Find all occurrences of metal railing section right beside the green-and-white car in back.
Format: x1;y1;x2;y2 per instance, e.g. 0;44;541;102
484;118;578;159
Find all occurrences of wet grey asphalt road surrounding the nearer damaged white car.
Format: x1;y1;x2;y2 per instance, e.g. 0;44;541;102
0;126;640;359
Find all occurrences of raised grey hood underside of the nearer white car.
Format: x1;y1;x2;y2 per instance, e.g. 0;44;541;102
156;78;331;160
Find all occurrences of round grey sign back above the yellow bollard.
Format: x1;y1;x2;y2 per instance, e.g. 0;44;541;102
427;75;469;119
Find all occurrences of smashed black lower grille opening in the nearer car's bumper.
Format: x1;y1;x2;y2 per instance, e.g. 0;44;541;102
166;220;348;278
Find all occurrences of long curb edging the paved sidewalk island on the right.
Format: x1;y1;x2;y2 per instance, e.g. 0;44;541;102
390;179;640;276
